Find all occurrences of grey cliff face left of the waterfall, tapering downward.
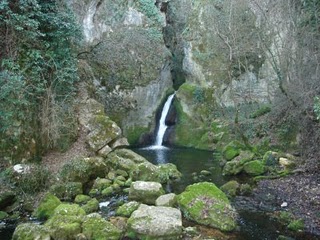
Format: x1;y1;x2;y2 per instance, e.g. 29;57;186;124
69;0;172;142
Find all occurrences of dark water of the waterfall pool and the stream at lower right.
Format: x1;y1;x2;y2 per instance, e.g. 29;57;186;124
132;148;317;240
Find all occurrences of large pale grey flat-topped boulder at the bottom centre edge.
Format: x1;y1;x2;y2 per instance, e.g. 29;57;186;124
128;204;182;240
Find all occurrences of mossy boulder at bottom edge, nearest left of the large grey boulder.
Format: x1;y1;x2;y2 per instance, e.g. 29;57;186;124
82;213;121;240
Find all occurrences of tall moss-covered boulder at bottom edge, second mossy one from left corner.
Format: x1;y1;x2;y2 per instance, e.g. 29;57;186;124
45;203;86;240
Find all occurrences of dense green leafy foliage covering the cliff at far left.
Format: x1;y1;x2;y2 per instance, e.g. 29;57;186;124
0;0;80;163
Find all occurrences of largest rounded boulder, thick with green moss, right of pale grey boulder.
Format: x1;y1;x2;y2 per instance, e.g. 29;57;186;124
178;182;237;231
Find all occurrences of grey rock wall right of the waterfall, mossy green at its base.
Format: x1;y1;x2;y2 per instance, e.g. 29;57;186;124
167;0;294;148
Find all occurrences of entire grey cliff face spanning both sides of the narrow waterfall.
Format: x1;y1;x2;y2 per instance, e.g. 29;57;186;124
68;0;314;152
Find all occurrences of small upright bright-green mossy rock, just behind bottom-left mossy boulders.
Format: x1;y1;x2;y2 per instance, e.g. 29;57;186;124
33;193;61;219
